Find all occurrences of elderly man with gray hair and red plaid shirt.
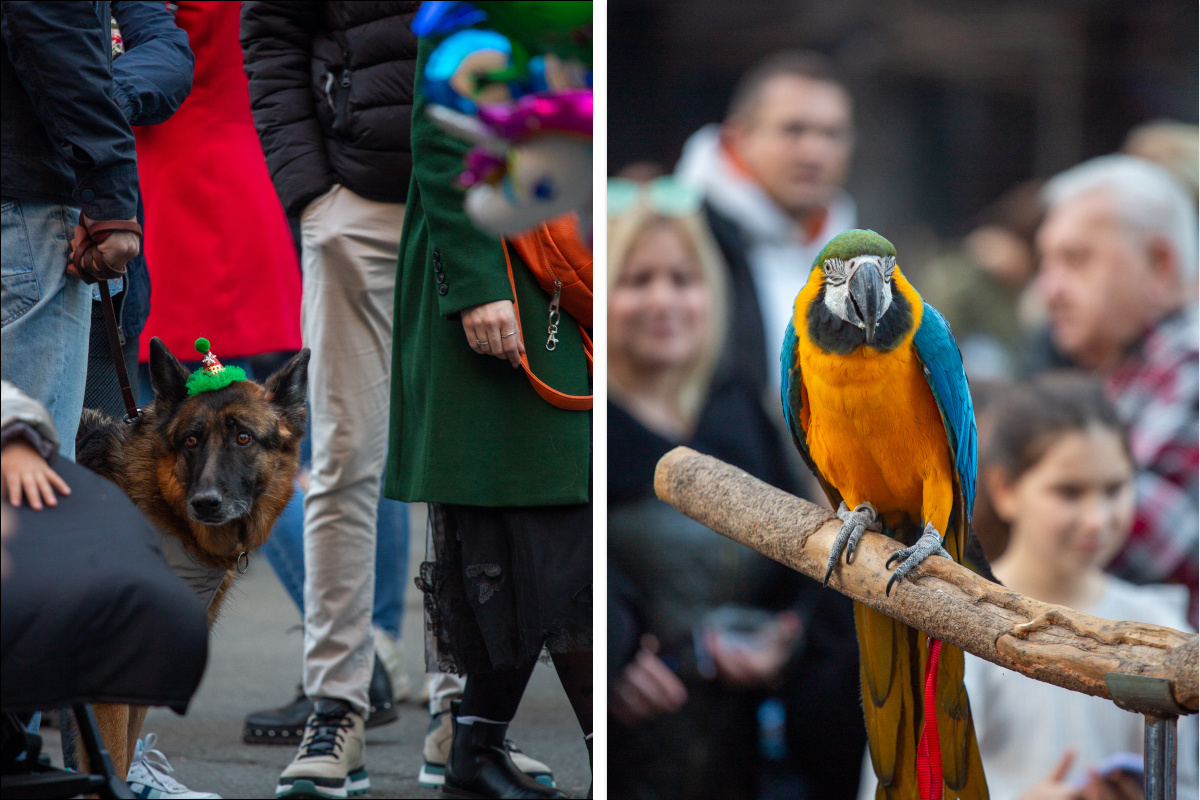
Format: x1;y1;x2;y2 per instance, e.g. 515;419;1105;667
1037;155;1200;625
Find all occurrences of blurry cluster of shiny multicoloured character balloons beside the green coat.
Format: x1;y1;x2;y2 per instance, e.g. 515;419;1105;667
413;0;592;235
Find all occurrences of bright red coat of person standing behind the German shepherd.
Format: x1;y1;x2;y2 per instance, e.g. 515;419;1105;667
134;0;301;361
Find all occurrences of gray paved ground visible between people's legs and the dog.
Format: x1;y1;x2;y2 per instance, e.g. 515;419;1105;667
46;509;590;798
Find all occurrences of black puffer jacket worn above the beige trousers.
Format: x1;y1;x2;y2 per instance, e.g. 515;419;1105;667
241;0;421;216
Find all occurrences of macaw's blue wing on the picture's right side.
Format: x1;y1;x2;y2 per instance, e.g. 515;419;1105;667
912;302;978;528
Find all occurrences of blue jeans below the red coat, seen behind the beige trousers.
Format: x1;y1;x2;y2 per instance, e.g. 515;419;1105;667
138;351;408;638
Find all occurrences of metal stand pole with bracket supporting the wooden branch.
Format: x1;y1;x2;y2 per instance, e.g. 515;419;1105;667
1104;672;1187;800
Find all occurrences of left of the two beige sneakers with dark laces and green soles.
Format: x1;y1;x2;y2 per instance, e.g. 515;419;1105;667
275;697;371;800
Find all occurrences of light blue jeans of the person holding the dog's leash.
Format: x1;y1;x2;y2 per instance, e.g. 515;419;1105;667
0;200;91;461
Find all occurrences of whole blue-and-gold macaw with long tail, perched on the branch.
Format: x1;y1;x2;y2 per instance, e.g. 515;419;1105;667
781;230;988;799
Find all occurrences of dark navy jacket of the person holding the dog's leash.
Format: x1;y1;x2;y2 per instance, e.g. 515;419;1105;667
0;0;146;219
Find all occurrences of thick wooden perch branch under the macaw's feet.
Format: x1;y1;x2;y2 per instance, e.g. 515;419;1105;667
654;447;1200;714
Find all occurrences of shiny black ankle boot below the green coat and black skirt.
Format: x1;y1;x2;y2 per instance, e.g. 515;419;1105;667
442;700;566;799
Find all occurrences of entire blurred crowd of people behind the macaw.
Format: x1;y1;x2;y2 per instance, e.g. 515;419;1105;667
607;52;1200;800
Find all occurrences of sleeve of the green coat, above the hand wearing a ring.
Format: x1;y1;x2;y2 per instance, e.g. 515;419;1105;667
413;37;514;317
